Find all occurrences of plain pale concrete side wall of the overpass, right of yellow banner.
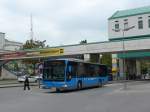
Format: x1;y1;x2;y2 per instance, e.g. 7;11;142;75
58;37;150;55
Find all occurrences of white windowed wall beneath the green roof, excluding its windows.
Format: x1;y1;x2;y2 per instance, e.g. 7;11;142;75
108;14;150;39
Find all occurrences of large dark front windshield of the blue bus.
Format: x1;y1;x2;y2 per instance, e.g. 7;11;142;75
43;60;65;81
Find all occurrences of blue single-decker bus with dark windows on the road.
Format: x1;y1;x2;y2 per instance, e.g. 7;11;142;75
43;59;108;91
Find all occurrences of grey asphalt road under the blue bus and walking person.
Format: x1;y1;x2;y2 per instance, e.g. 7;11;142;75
0;82;150;112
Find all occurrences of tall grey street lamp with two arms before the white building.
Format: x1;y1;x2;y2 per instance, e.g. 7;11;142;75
112;24;135;90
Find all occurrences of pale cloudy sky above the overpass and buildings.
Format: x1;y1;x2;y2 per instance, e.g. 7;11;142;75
0;0;150;46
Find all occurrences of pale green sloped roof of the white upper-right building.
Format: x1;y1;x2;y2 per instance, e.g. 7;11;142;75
109;6;150;20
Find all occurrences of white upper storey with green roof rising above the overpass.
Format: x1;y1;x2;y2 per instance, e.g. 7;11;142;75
108;6;150;40
